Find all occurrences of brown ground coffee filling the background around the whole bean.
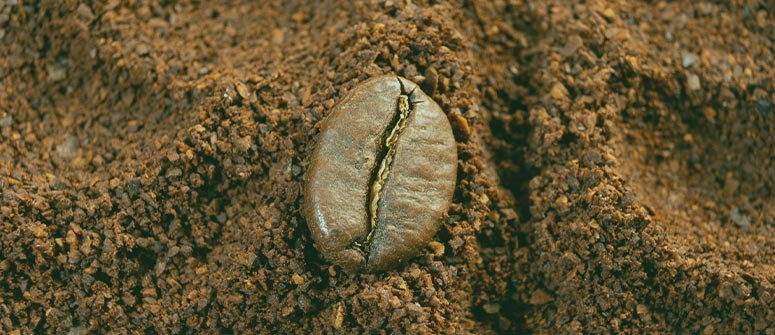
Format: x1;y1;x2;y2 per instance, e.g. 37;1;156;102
0;0;775;334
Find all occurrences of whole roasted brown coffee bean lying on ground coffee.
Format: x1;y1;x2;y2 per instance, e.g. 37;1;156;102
304;76;457;272
